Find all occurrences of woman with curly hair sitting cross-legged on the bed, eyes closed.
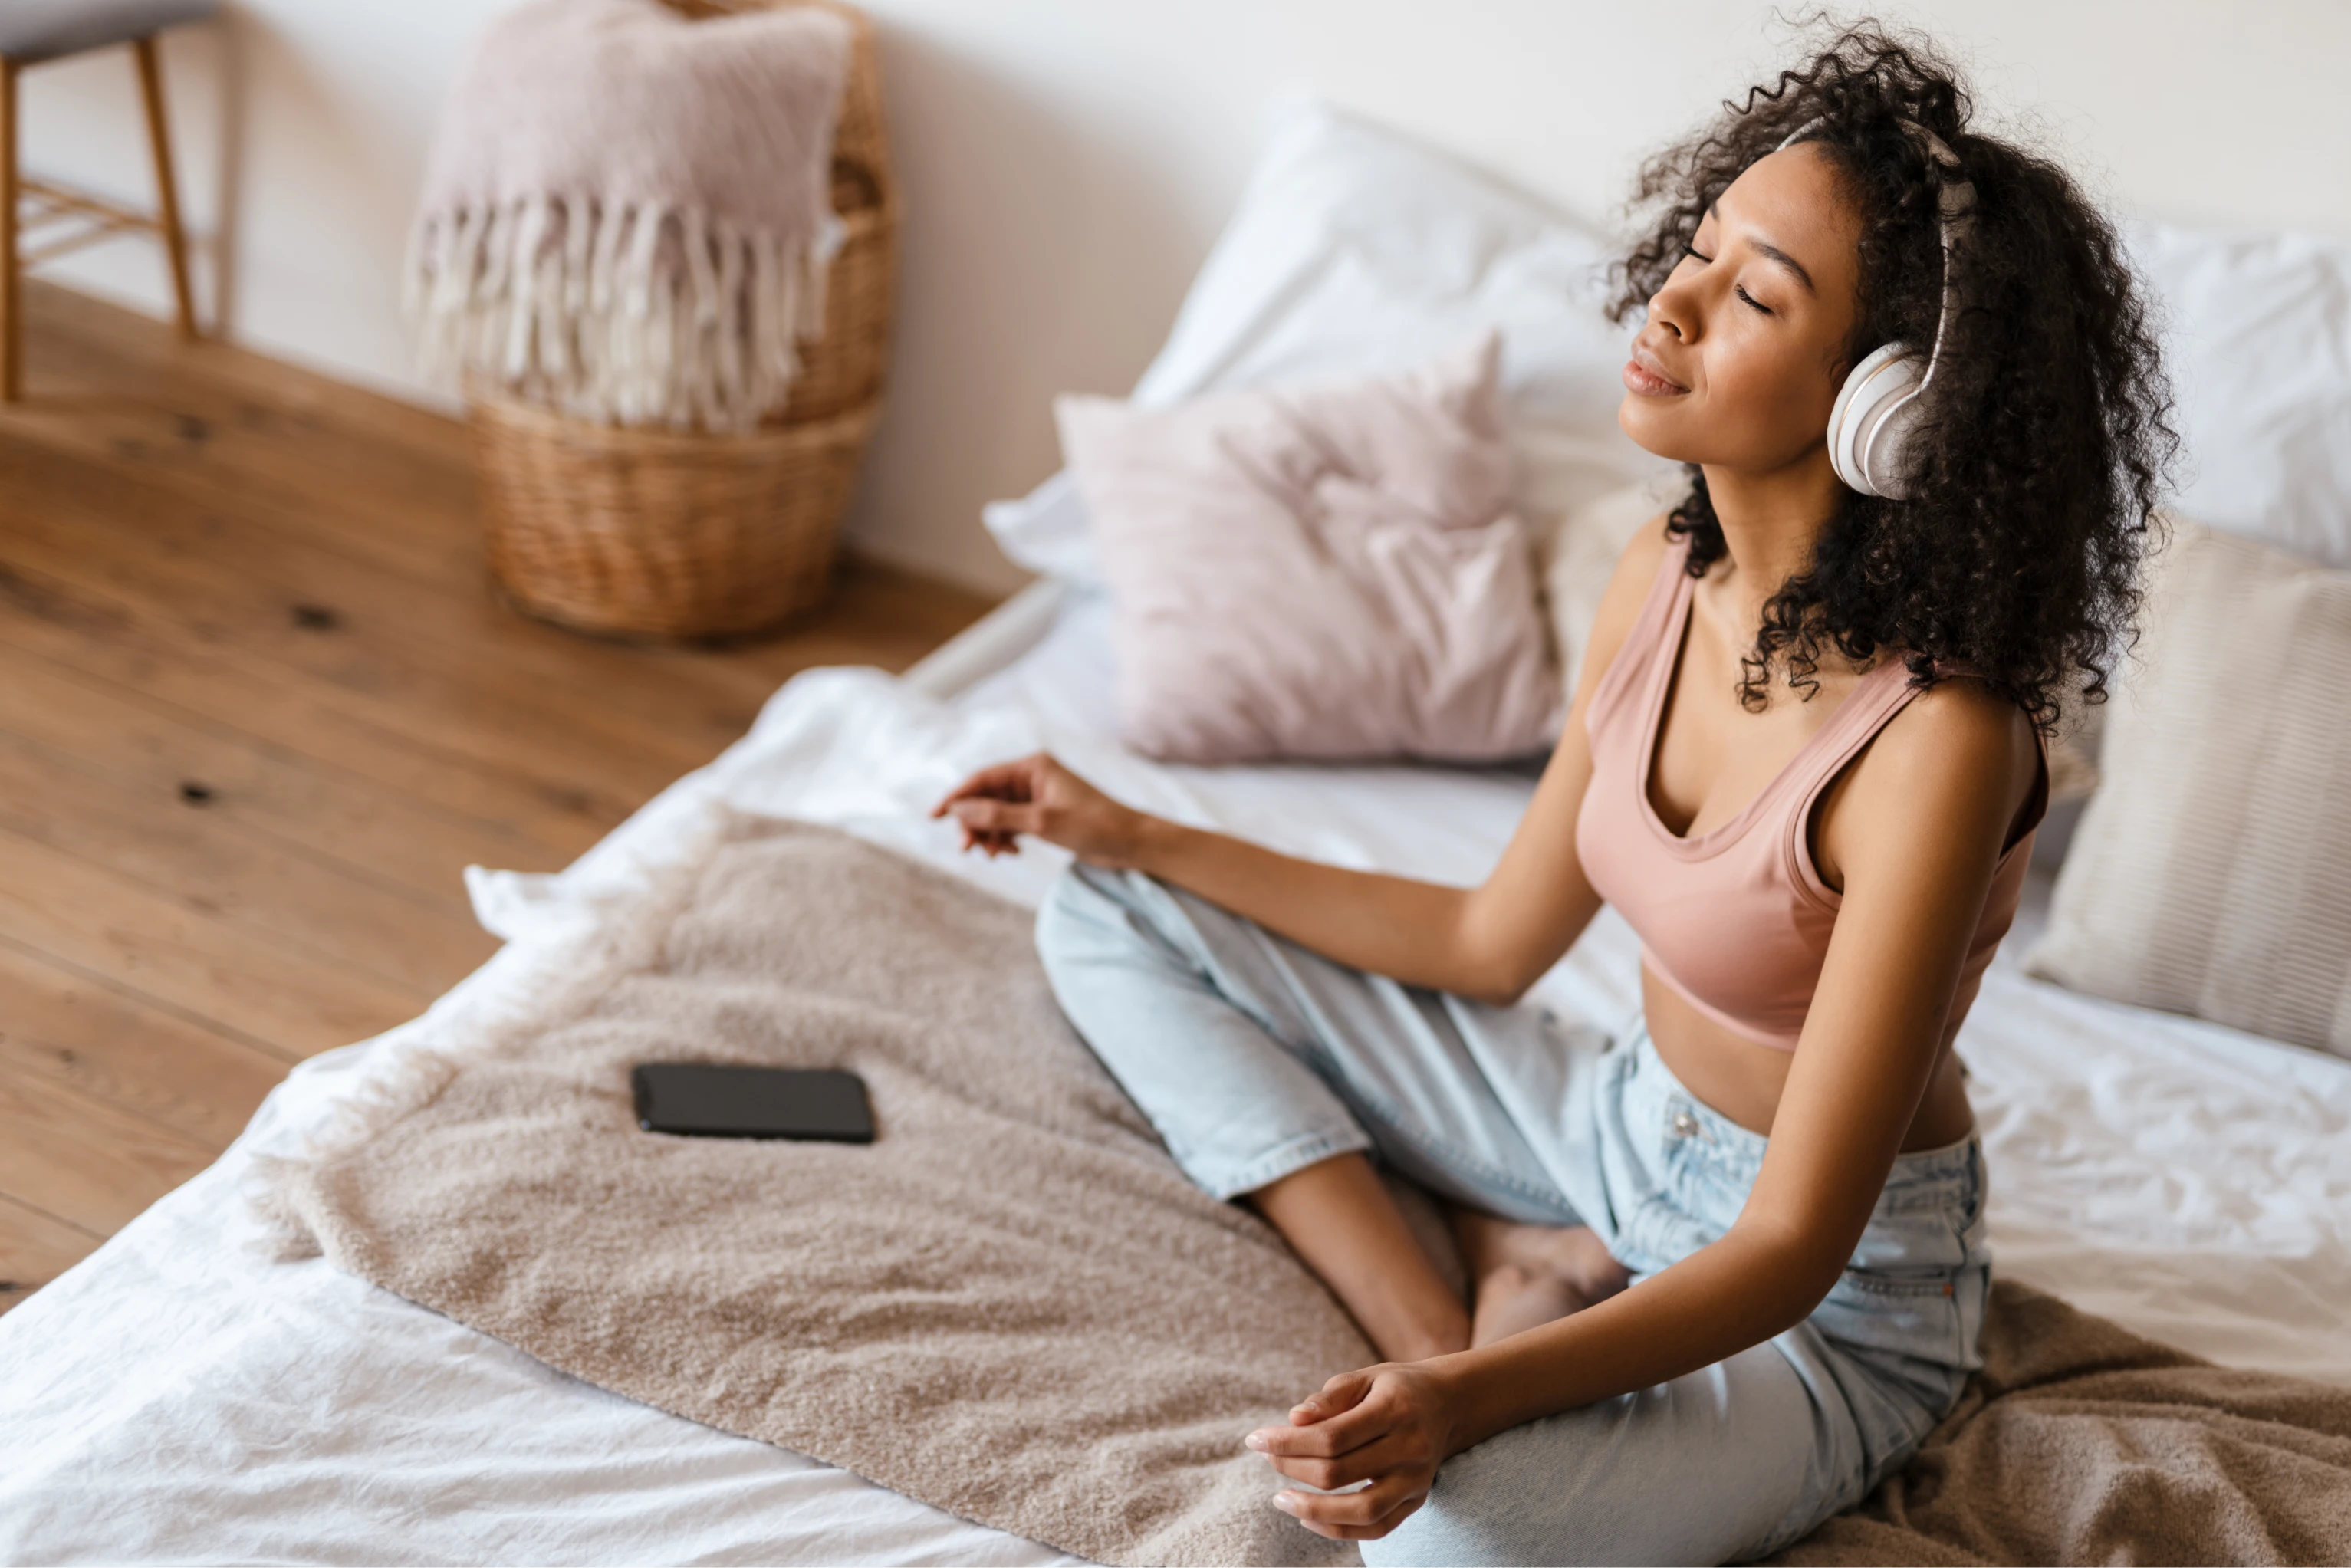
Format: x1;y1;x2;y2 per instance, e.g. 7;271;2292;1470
940;28;2172;1566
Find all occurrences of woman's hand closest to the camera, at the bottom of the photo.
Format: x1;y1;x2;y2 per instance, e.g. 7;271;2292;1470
1248;1361;1455;1540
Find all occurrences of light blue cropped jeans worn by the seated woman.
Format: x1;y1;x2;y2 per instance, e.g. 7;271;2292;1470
1037;865;1991;1568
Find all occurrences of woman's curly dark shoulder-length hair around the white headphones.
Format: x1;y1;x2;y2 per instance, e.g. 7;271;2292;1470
1608;19;2179;731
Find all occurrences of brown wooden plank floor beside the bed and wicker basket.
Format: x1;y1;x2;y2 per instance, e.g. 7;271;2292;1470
0;284;988;1312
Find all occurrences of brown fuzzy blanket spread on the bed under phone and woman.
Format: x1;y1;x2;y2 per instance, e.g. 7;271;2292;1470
271;820;2351;1568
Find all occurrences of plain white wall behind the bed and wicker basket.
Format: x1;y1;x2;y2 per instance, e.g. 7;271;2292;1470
26;0;2351;587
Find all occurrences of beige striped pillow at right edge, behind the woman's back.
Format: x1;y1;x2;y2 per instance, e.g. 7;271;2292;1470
2024;522;2351;1056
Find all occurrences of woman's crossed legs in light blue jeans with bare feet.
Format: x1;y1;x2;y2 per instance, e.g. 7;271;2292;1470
1039;865;1869;1568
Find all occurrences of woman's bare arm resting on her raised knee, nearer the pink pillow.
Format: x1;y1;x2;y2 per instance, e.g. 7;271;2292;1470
933;518;1665;1001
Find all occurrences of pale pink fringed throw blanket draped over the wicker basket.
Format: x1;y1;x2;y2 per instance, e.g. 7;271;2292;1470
404;0;851;430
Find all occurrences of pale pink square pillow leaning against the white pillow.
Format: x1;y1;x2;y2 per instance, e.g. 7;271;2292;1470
1056;334;1559;761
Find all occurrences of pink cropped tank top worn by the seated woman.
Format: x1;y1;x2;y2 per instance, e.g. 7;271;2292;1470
1575;536;2047;1050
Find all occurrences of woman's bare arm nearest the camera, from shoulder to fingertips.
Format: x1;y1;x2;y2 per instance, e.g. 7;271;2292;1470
1251;684;2034;1535
